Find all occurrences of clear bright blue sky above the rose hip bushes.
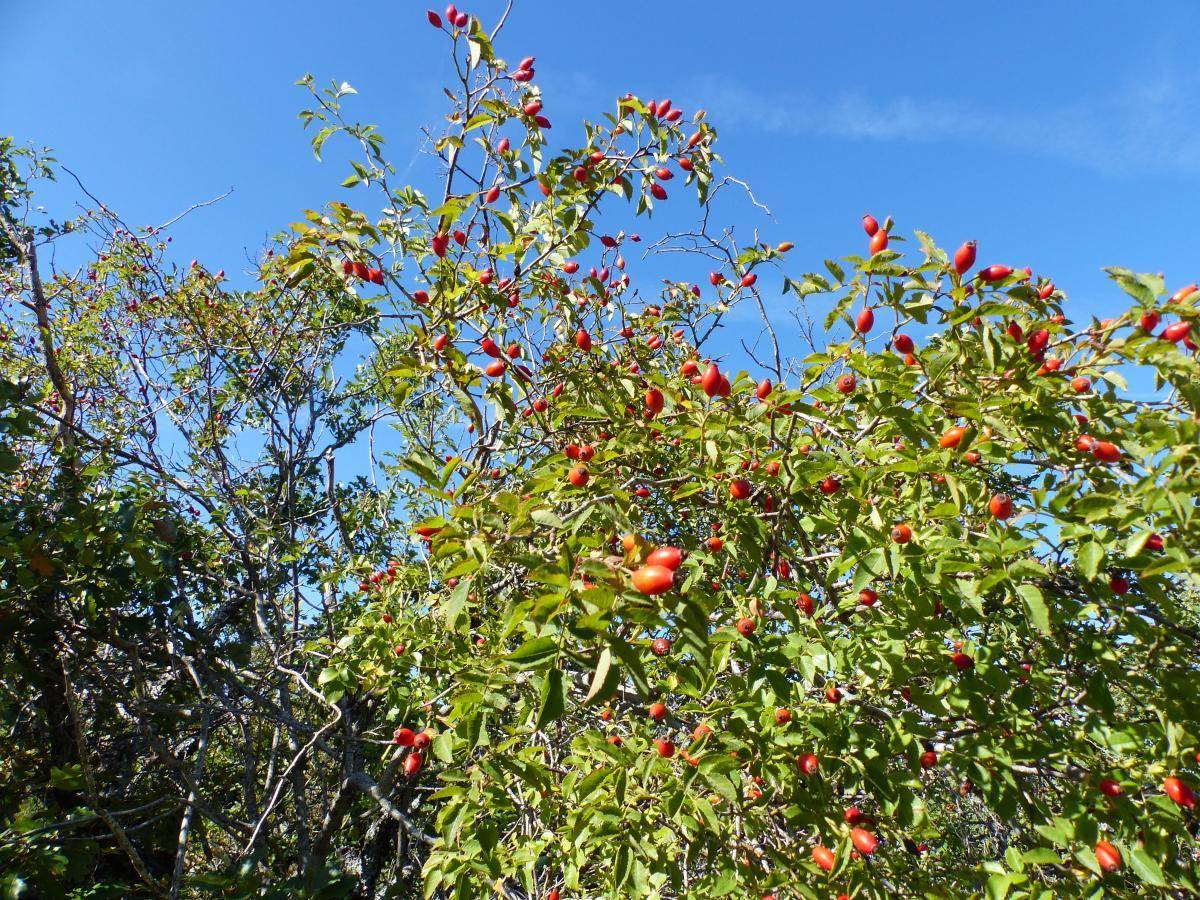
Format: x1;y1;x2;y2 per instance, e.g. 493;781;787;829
0;0;1200;374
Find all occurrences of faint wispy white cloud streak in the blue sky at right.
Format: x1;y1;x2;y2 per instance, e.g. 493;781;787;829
695;76;1200;176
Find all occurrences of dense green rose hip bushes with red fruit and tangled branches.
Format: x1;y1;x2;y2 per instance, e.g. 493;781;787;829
0;10;1200;898
